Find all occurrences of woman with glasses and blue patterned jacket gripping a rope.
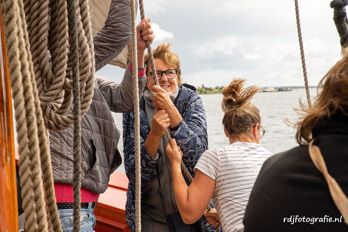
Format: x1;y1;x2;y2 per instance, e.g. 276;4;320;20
123;44;213;232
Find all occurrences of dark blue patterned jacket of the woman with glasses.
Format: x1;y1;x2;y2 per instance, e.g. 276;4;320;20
123;84;211;231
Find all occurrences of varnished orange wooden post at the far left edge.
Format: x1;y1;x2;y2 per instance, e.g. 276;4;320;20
0;9;18;231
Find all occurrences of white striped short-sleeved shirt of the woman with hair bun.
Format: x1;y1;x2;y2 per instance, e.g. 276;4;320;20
195;141;271;231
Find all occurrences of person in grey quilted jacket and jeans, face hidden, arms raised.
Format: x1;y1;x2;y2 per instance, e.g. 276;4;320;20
49;0;154;231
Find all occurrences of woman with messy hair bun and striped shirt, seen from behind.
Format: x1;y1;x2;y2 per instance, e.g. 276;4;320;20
166;79;271;232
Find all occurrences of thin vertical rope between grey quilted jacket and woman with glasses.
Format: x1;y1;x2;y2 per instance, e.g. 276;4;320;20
131;0;141;232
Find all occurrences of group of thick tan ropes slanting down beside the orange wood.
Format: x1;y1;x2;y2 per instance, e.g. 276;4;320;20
1;0;61;232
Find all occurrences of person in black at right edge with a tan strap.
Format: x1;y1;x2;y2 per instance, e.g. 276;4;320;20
244;57;348;232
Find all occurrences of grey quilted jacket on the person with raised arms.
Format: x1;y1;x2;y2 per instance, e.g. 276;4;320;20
49;0;146;193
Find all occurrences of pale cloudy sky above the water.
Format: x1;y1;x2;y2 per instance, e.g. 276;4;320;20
97;0;341;87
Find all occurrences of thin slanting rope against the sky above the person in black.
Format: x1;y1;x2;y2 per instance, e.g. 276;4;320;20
294;0;312;107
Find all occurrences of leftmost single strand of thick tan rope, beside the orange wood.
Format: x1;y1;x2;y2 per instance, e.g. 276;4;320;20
1;0;38;231
